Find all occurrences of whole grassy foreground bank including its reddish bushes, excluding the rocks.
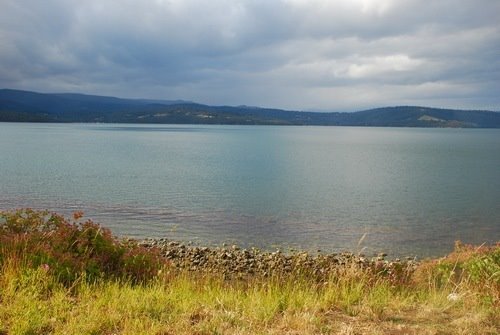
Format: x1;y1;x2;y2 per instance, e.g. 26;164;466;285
0;210;500;335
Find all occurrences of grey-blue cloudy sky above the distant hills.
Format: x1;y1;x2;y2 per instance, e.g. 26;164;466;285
0;0;500;111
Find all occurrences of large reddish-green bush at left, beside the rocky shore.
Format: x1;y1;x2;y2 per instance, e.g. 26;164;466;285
0;209;164;284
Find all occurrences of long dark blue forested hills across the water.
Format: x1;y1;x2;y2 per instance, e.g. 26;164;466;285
0;89;500;128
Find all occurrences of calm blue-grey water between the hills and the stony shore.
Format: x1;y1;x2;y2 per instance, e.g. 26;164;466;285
0;123;500;257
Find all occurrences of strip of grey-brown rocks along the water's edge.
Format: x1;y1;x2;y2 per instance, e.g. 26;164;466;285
139;239;418;281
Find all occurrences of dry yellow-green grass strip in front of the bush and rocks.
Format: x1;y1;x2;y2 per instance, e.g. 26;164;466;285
0;265;500;335
